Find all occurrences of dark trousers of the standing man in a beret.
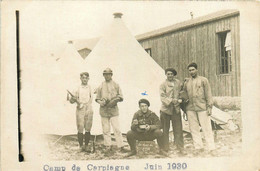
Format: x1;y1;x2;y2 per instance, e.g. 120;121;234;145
160;112;184;151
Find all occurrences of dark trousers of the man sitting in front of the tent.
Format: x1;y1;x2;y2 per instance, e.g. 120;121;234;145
126;129;163;151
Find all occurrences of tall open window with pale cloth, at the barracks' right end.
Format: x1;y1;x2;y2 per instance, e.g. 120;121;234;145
218;31;232;74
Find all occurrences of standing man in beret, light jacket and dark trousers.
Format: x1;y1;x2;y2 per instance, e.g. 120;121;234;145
160;68;185;155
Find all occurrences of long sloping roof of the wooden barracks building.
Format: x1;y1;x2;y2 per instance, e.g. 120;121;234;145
135;9;239;41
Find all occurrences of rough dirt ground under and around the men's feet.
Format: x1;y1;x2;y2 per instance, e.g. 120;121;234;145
46;110;242;160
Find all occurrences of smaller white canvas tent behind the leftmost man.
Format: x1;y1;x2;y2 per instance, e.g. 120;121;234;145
45;42;104;135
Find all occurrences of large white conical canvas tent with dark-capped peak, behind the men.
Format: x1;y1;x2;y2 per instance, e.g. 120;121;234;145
85;14;165;133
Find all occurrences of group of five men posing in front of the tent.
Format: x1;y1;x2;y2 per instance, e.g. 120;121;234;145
69;63;216;157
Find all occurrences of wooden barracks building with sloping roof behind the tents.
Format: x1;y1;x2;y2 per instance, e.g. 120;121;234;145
74;10;241;96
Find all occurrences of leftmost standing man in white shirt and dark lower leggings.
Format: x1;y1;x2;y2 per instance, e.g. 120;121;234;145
69;72;93;152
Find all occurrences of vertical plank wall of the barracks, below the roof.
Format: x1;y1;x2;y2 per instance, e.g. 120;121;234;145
139;16;241;96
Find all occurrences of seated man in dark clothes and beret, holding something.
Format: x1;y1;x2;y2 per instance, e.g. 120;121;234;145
126;99;167;157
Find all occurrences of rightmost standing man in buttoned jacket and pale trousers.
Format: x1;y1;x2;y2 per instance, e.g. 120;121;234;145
184;63;216;155
